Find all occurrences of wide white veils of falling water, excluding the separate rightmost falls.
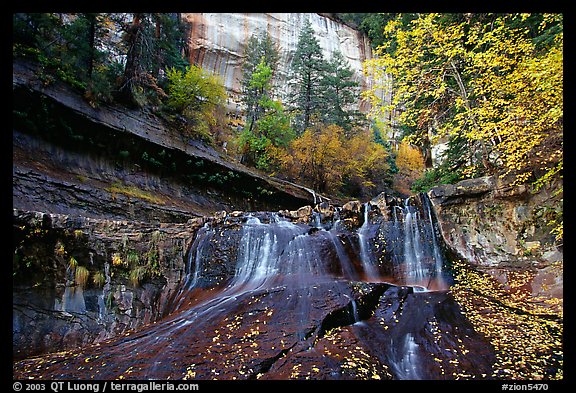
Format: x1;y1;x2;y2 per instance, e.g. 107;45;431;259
186;214;358;293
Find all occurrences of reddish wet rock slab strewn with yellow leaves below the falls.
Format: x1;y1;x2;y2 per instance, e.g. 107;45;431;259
14;281;494;379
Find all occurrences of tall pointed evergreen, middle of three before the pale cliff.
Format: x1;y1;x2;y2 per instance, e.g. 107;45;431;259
290;20;326;135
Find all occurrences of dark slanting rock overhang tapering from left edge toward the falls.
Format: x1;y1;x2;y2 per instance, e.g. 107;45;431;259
13;59;315;222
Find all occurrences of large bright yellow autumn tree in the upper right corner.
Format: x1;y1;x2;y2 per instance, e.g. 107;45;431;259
366;14;563;239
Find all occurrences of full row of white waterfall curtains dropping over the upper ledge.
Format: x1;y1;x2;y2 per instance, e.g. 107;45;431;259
181;191;446;302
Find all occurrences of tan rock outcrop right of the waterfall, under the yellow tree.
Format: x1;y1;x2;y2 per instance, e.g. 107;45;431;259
428;177;563;303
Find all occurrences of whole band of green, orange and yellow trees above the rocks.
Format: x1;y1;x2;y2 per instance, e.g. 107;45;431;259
13;13;563;211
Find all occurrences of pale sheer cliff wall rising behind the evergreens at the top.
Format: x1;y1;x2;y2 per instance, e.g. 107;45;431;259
182;13;372;110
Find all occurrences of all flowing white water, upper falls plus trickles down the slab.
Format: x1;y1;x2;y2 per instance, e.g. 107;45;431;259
171;194;445;379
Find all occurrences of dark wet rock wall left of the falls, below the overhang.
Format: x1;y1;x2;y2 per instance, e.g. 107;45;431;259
12;210;204;358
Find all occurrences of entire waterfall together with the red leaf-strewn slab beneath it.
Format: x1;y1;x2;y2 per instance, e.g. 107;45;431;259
16;192;494;379
